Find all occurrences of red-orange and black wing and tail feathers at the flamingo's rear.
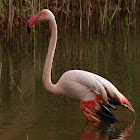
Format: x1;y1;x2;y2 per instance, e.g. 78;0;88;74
80;95;136;123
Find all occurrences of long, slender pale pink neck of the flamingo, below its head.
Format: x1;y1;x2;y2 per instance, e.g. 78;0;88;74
42;19;57;94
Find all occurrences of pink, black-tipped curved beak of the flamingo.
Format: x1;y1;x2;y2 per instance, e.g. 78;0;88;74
27;14;40;34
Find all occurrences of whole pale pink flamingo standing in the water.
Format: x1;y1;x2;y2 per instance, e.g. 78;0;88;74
27;9;136;122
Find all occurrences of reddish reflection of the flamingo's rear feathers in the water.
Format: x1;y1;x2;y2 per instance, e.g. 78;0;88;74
81;120;135;140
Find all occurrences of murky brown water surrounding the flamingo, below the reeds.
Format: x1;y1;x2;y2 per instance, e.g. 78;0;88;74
0;18;140;140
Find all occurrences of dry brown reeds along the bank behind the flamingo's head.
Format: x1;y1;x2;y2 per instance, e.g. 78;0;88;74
0;0;140;36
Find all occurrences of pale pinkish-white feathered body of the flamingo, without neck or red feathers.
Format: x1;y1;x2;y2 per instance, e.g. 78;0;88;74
57;70;119;102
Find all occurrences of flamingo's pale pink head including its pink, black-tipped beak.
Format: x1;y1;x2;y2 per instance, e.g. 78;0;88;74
27;9;55;33
